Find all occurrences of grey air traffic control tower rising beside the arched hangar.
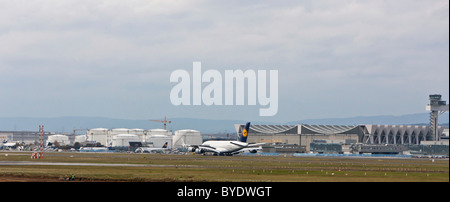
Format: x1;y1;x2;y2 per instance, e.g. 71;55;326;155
426;94;448;141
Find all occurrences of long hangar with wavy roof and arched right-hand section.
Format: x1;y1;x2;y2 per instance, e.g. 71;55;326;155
235;124;445;151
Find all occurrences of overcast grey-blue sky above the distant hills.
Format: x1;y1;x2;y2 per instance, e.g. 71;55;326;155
0;0;449;122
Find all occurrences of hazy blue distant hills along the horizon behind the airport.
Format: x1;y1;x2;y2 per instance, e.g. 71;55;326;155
0;113;449;134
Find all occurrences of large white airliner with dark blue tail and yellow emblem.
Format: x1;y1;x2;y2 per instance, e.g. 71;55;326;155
188;122;265;156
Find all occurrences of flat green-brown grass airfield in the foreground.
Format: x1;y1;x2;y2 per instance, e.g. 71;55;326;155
0;152;449;182
